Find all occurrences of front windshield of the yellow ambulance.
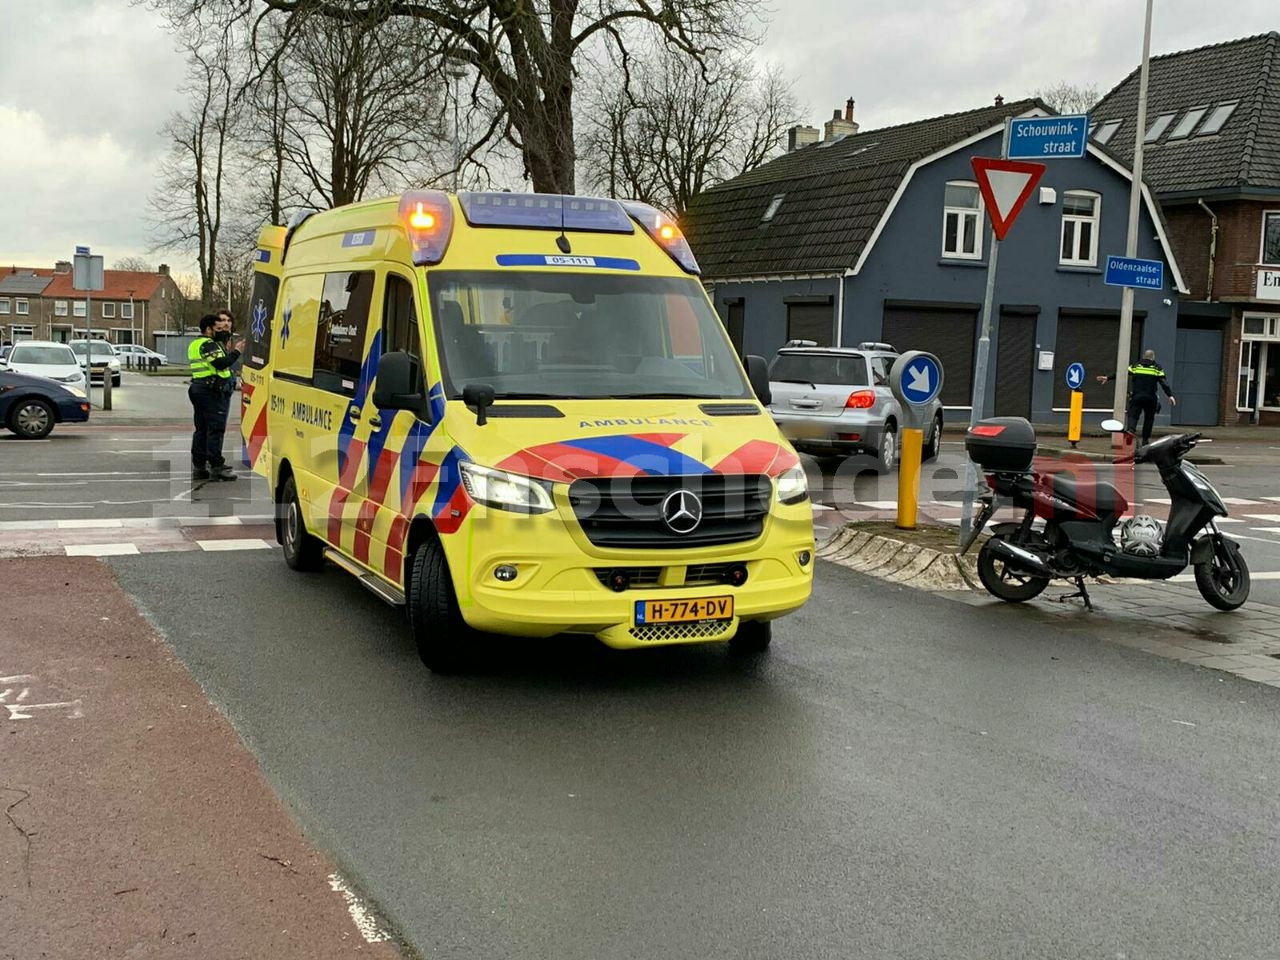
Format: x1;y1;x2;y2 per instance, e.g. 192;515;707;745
428;270;753;399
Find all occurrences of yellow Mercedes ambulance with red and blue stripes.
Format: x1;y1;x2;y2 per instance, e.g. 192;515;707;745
241;191;814;671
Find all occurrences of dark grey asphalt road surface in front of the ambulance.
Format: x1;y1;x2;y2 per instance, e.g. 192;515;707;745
110;552;1280;960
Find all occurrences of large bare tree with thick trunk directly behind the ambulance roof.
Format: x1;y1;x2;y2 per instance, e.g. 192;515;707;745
152;0;763;193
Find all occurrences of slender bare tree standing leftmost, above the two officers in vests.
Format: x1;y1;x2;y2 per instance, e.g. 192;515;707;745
151;29;237;303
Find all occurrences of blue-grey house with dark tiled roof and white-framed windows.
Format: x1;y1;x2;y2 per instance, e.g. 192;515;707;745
684;100;1185;422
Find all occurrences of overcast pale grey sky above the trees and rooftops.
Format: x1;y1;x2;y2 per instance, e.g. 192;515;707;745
0;0;1280;280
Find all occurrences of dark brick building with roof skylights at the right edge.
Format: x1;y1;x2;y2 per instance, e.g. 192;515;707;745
1092;32;1280;424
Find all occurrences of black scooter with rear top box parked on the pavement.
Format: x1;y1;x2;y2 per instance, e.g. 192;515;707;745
960;417;1249;611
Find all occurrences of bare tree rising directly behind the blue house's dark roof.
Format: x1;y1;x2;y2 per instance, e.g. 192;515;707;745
582;49;799;216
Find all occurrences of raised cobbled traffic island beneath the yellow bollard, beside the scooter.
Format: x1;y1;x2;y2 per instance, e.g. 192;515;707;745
818;520;980;591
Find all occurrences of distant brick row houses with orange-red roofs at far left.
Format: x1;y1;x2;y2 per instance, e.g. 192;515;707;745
0;260;184;349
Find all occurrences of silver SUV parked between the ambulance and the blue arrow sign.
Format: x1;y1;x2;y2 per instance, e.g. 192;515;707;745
769;340;942;471
